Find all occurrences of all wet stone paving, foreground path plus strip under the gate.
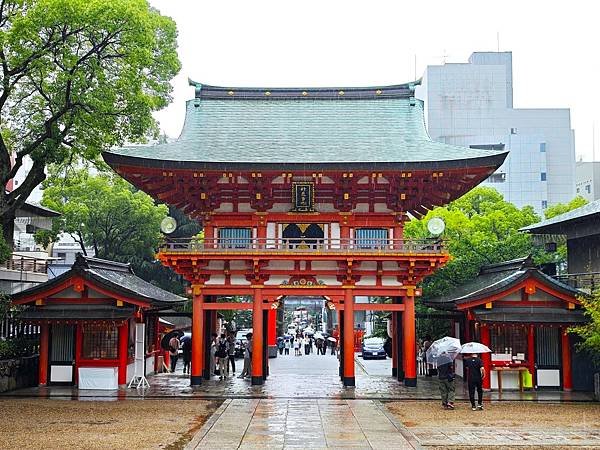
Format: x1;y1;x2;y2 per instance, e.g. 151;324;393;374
4;355;600;449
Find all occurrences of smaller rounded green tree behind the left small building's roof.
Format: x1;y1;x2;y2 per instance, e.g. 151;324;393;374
37;170;168;260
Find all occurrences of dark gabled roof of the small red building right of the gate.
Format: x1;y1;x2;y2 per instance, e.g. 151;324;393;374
425;256;583;309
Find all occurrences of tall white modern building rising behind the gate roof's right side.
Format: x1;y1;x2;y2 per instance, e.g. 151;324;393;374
419;52;575;213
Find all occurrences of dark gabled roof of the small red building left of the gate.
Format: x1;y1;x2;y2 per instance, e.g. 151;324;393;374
12;254;186;308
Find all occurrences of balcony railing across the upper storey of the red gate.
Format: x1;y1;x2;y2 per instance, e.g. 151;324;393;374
160;238;446;254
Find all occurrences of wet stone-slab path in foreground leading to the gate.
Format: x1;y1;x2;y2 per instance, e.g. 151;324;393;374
186;399;419;450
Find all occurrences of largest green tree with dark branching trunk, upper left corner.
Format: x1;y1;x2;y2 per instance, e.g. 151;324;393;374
0;0;180;245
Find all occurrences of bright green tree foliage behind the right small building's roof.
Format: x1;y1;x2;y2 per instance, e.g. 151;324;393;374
404;187;539;298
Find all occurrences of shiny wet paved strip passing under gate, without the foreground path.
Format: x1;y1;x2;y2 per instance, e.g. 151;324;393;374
8;354;593;401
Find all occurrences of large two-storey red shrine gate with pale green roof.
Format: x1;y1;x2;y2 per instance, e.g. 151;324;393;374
104;82;506;386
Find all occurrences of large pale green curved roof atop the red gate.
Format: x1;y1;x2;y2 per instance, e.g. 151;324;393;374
105;81;507;165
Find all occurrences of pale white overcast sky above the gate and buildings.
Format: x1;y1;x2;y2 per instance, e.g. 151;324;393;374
150;0;600;160
